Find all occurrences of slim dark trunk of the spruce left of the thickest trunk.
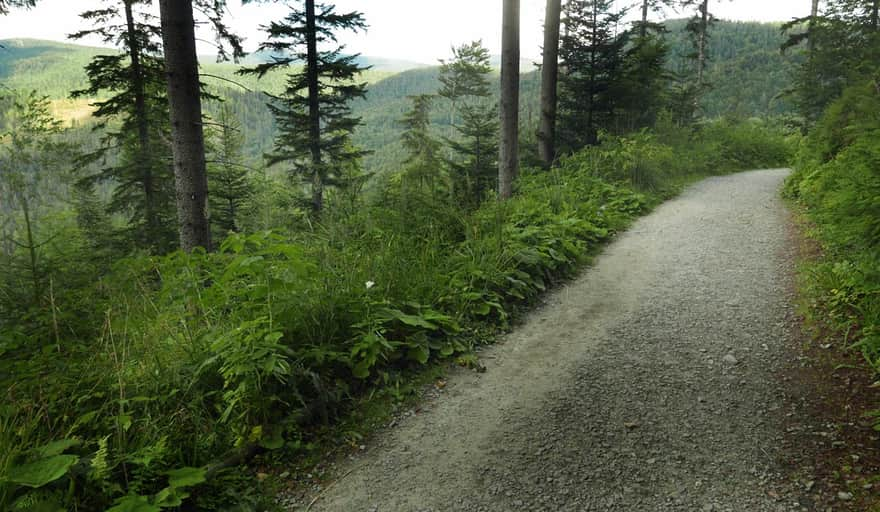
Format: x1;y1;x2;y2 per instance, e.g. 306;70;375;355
124;0;159;248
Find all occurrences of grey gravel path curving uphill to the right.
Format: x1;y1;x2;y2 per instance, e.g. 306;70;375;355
300;170;802;512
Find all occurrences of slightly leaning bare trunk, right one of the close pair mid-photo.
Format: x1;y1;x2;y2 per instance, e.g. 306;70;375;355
538;0;560;168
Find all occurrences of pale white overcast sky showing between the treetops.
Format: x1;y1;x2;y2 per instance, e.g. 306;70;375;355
0;0;809;63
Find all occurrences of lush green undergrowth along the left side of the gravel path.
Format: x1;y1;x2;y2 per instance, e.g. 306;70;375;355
0;119;788;512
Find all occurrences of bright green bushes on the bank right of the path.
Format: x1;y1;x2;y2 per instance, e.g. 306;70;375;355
785;82;880;506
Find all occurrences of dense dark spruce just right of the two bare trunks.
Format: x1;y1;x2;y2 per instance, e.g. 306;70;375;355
559;0;627;151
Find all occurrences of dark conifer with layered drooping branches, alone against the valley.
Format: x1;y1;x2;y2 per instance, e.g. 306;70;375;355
245;0;367;215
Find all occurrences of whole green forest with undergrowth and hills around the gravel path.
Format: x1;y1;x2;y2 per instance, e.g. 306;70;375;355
0;0;880;512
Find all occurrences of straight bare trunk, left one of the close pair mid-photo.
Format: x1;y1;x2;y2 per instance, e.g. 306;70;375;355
498;0;519;199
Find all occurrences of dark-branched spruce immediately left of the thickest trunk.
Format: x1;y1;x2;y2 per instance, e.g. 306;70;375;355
70;0;177;253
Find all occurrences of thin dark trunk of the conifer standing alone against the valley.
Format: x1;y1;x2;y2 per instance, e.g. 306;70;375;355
306;0;324;214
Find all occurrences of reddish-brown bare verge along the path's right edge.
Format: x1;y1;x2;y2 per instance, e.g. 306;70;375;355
780;210;880;511
